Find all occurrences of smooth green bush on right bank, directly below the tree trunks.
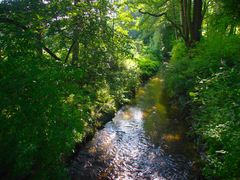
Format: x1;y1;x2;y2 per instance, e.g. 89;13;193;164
166;33;240;97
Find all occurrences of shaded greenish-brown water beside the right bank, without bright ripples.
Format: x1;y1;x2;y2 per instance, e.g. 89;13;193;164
136;75;197;158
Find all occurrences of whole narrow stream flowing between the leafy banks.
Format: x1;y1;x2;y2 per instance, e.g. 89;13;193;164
70;77;200;180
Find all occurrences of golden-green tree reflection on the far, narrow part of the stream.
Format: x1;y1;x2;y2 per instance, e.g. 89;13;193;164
136;77;169;144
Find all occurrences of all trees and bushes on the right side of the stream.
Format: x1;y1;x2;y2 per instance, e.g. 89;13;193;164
130;0;240;179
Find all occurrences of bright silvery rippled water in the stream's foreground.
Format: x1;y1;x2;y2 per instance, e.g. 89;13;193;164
70;107;191;180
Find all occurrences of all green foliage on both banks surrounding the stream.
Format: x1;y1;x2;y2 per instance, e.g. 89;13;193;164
0;0;240;179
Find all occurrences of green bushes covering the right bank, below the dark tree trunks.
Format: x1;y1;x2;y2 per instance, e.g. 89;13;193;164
165;33;240;179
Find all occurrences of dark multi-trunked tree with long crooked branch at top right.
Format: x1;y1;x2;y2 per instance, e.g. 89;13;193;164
135;0;207;47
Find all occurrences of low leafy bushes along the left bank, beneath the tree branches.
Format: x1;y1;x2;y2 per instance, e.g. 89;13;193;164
0;54;139;179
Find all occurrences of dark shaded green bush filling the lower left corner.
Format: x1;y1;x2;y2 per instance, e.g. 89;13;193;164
0;57;90;179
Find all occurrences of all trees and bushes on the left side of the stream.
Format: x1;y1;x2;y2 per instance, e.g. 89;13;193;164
0;0;152;179
